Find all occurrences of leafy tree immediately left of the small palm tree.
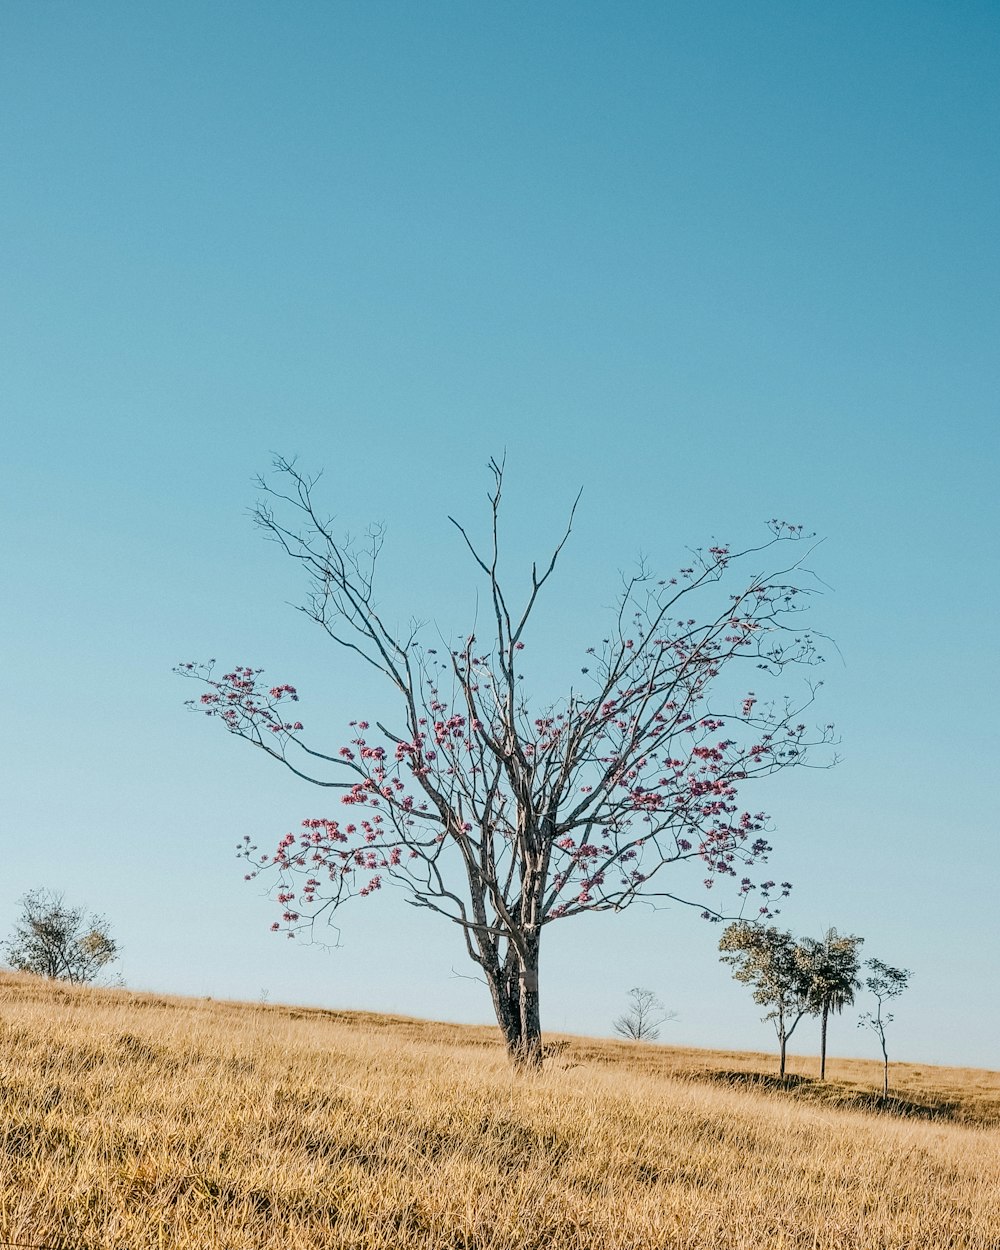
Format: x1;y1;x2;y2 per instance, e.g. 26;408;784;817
719;920;815;1080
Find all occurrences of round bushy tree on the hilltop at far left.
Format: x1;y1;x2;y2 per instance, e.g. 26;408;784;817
4;890;119;984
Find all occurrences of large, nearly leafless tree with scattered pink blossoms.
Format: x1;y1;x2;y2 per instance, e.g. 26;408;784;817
178;460;830;1066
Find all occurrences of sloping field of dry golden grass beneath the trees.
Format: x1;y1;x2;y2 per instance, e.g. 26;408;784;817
0;974;1000;1250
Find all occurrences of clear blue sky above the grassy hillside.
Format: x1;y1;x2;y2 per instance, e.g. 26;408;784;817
0;0;1000;1068
